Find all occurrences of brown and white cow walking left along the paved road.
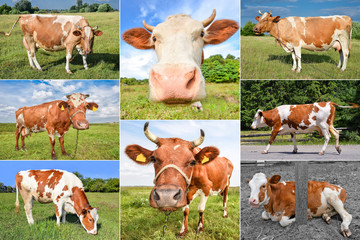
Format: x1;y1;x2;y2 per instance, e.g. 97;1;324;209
251;102;360;155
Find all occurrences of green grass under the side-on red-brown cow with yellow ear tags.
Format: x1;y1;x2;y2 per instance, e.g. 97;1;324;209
0;123;119;160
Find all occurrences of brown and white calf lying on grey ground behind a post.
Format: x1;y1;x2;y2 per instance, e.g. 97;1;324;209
249;173;352;237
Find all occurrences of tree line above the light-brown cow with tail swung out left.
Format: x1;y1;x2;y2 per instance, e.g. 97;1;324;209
0;0;114;14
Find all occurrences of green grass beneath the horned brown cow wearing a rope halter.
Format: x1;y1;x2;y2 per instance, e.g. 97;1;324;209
121;187;240;240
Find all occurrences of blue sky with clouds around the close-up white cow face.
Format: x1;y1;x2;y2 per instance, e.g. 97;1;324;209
120;0;240;79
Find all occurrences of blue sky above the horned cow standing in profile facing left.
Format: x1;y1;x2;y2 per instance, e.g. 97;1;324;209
241;0;360;26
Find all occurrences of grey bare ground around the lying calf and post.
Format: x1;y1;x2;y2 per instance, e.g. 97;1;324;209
241;162;360;240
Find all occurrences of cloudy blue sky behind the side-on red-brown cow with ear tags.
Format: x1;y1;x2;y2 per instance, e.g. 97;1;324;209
0;80;120;123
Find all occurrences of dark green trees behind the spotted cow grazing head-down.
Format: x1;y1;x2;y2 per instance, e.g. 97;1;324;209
0;172;120;193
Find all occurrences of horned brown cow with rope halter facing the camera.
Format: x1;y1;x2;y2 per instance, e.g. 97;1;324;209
125;122;233;236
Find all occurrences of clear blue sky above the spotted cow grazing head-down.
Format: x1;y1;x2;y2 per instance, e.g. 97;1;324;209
0;161;119;187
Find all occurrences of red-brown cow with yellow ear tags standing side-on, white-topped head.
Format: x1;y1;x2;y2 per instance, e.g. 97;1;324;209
15;93;99;159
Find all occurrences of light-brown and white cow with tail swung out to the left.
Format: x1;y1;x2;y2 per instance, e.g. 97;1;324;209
2;14;103;73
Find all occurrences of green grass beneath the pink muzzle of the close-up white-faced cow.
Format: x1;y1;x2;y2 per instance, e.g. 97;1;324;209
121;83;240;120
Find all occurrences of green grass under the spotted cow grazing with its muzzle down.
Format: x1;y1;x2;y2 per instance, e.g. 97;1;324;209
0;193;119;240
